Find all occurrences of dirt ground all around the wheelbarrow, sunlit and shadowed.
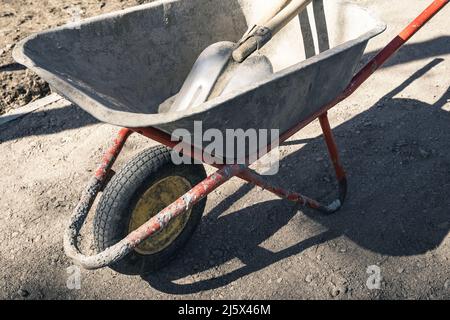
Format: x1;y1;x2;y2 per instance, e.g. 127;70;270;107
0;0;450;299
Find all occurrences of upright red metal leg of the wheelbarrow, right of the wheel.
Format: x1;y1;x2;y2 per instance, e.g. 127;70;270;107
319;112;347;204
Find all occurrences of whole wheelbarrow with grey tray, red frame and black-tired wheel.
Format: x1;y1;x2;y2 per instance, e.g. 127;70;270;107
14;0;449;274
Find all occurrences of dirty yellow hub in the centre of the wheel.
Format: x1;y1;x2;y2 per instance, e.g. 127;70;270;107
128;176;192;255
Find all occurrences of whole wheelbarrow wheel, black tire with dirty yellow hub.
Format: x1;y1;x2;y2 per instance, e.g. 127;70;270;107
94;147;206;275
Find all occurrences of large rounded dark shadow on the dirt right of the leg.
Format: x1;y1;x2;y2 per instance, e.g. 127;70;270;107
296;59;450;256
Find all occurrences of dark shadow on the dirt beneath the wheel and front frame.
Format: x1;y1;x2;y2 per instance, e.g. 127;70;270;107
144;194;336;294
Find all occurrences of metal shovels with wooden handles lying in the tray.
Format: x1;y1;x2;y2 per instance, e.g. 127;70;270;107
170;0;313;112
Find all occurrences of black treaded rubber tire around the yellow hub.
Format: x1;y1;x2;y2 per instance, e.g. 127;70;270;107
94;146;206;275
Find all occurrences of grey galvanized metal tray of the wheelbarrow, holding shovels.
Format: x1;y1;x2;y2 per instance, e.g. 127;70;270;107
14;0;386;156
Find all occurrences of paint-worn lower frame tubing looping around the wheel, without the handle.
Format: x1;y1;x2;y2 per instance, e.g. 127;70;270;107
64;120;346;270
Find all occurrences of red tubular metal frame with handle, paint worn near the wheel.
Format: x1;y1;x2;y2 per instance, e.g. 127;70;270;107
64;0;450;269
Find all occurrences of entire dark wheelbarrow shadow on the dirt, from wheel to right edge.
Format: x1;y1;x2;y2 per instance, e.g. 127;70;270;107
145;59;450;294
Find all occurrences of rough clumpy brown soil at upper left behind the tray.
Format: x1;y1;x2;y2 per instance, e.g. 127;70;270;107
0;0;154;114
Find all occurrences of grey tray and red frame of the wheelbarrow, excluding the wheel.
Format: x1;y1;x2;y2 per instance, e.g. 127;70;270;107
14;0;448;269
